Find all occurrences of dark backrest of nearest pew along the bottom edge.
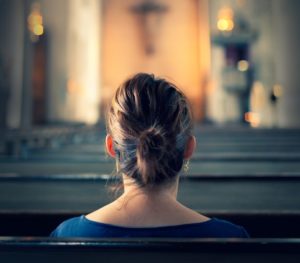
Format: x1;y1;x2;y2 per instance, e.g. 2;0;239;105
0;237;300;263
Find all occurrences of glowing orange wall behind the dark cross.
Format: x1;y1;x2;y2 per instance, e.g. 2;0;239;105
102;0;210;120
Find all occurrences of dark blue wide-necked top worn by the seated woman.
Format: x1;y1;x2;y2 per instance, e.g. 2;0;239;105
51;215;249;238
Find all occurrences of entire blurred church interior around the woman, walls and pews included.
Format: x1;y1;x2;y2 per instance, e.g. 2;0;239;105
0;0;300;243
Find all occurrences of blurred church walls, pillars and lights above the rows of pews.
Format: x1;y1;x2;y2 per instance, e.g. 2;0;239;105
0;0;300;129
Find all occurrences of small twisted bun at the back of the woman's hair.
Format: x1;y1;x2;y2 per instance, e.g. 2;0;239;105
137;127;166;160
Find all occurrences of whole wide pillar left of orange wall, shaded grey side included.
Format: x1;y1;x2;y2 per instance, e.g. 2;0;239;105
40;0;102;124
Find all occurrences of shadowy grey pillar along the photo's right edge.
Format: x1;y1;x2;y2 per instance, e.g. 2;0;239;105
270;0;300;127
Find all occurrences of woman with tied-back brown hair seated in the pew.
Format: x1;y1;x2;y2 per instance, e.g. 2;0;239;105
51;73;248;237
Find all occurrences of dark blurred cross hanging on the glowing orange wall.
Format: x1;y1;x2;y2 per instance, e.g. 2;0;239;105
130;0;168;55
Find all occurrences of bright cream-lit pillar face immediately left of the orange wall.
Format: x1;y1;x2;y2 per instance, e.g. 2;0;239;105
64;0;101;124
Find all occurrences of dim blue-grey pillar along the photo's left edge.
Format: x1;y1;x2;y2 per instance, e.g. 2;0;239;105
0;0;26;128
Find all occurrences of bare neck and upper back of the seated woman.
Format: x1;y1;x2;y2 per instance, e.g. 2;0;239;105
87;178;208;227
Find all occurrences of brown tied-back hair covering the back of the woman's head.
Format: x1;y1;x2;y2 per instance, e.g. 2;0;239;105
107;73;192;187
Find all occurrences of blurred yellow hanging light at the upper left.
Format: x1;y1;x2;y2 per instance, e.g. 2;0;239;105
27;3;44;42
